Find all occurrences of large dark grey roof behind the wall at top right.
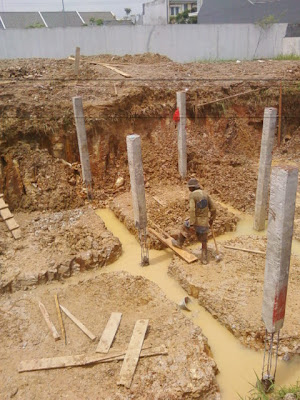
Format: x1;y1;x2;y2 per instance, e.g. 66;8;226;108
198;0;300;24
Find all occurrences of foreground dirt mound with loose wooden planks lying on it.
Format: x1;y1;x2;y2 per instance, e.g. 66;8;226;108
0;273;220;400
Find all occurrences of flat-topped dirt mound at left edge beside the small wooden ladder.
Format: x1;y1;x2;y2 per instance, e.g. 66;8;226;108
0;207;122;292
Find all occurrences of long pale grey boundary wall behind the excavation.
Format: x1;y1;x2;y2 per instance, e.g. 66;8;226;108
0;24;290;62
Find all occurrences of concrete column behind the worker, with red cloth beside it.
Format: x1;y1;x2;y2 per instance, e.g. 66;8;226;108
177;92;187;179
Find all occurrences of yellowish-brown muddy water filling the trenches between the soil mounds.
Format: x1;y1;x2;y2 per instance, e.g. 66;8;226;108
97;209;300;400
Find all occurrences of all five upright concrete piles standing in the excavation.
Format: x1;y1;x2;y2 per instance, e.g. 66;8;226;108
73;92;298;383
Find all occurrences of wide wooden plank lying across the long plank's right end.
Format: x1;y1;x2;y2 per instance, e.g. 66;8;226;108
118;319;149;389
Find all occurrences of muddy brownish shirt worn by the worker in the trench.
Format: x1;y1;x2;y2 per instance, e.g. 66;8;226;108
189;189;216;227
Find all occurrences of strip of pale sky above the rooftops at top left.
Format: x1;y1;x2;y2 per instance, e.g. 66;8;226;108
0;0;146;18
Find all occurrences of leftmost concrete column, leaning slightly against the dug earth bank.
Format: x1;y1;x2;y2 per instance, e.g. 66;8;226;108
73;97;92;185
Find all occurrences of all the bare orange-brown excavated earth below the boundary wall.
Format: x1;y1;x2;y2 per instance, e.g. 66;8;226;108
0;54;300;400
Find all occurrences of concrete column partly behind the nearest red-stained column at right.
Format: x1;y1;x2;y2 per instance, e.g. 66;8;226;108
253;107;277;231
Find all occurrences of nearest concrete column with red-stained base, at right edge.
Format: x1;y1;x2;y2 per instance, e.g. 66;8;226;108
262;166;298;333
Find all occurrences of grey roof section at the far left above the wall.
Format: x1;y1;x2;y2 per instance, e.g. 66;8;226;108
0;12;45;29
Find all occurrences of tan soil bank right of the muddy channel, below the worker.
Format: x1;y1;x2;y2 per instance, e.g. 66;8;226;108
169;236;300;355
